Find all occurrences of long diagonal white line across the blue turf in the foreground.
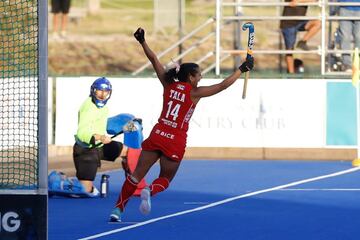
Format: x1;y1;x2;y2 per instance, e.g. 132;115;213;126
79;167;360;240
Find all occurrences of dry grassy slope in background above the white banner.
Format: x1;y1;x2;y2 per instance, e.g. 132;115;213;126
49;0;320;76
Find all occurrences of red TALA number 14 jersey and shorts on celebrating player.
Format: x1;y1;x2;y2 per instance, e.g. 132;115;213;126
142;82;196;161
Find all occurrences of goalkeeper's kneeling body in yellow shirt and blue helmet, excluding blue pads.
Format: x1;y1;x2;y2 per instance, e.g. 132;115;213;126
73;77;127;193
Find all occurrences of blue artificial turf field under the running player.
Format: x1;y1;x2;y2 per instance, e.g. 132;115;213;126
49;160;360;240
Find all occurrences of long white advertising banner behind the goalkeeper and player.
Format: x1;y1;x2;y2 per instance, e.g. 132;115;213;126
55;77;326;147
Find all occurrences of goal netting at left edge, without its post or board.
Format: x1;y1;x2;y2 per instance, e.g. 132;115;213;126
0;0;39;189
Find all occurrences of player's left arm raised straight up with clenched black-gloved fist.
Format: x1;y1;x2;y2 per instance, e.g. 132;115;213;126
134;28;167;87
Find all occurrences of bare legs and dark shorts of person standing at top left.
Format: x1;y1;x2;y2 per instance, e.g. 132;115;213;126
51;0;71;37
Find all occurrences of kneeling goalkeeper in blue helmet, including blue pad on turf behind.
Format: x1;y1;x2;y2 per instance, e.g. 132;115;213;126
49;77;134;197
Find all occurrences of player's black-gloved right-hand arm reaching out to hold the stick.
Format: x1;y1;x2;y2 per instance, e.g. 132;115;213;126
191;57;254;103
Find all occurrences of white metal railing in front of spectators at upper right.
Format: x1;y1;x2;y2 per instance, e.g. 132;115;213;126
215;0;360;75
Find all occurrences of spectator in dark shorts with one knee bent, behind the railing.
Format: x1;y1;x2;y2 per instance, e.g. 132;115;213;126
280;0;321;73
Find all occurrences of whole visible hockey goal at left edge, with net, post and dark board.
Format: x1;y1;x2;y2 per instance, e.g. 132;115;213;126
0;0;48;239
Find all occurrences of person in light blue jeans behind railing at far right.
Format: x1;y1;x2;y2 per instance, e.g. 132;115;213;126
338;0;360;72
